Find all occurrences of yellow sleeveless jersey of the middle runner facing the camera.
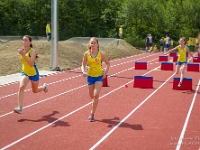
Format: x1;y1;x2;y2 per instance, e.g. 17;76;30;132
87;51;103;77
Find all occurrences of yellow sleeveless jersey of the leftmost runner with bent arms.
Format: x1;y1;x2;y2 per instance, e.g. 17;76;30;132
20;48;36;76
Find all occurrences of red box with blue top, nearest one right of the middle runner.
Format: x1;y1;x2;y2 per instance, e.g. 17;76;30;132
133;76;153;88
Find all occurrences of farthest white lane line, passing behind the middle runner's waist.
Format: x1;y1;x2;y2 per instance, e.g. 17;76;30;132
0;54;158;100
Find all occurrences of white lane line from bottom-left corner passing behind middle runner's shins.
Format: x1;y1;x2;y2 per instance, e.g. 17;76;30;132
1;62;159;150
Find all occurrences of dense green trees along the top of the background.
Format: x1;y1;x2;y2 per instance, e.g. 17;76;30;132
0;0;200;45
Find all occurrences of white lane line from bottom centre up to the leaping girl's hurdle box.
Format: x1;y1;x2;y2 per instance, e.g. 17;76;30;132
90;73;175;150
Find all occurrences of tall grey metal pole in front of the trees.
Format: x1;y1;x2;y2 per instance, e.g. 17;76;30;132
50;0;59;71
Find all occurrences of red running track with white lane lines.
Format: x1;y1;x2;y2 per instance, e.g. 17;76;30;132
0;53;200;150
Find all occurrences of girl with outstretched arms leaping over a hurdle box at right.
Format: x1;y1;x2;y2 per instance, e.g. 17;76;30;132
165;37;194;87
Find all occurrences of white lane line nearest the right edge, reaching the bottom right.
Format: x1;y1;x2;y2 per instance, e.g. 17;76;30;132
176;80;200;150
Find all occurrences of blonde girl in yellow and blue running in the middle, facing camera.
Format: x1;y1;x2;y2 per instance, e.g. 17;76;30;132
81;37;110;122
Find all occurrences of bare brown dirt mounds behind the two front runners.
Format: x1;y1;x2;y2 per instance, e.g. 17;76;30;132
0;40;143;76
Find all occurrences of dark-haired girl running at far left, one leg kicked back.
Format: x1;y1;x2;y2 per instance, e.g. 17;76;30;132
14;35;48;114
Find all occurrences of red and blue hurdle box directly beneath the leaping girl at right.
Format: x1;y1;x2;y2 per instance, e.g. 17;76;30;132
173;78;192;90
